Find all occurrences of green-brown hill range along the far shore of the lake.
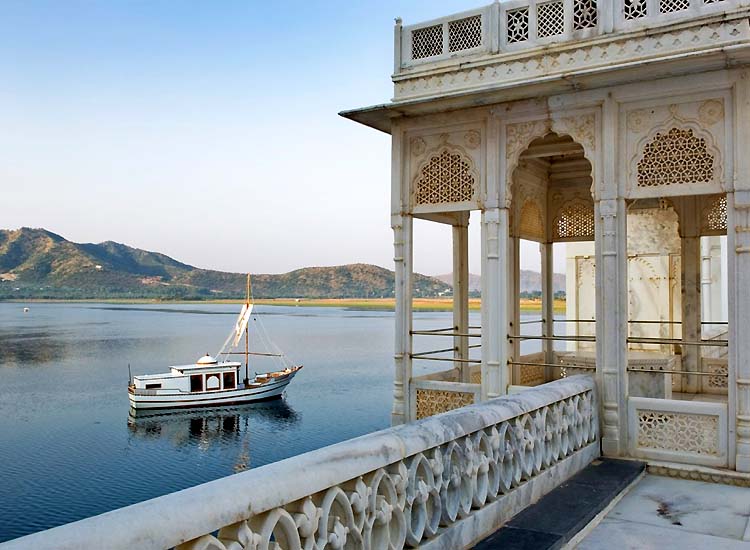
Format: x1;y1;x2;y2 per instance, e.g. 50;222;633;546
0;228;450;299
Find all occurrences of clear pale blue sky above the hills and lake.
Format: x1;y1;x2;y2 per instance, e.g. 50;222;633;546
0;0;557;274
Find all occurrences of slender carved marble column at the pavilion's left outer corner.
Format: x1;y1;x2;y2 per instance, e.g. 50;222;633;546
391;215;413;425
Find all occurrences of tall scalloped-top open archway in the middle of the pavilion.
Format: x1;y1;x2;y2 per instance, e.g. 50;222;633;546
508;133;596;387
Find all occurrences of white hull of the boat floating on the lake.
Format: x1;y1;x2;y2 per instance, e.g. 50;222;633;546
128;370;298;410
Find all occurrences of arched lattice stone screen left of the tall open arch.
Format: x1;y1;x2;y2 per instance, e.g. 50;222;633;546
414;150;476;205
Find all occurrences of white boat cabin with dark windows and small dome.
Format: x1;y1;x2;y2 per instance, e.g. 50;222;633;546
133;355;242;393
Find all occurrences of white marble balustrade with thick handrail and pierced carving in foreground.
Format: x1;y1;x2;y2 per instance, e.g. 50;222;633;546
0;375;599;550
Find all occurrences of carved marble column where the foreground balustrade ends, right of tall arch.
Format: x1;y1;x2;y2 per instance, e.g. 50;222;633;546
595;199;628;456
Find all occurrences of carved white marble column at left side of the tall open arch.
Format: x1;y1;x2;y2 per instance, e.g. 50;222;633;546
482;208;510;400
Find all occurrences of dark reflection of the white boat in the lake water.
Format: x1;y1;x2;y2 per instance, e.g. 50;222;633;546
128;399;300;472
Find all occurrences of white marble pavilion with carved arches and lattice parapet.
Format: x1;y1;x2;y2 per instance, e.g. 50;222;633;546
342;0;750;472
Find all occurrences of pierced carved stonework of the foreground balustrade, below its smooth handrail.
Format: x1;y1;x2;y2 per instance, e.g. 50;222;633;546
178;377;598;550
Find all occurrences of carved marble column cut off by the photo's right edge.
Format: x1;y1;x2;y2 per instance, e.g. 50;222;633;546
727;191;750;472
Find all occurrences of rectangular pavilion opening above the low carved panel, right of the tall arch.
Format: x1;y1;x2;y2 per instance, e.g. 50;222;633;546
627;195;728;402
